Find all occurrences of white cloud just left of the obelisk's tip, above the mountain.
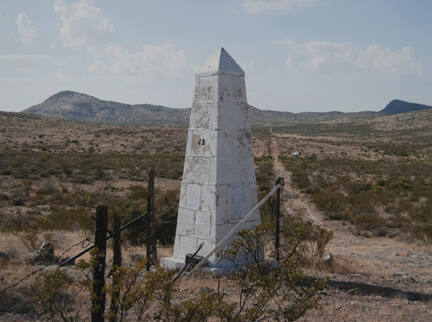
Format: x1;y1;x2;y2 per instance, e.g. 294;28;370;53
89;43;187;78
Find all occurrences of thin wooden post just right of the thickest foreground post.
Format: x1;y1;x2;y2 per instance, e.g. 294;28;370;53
109;212;122;322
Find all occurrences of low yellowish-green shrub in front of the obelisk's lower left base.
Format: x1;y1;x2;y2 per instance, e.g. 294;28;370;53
72;261;235;321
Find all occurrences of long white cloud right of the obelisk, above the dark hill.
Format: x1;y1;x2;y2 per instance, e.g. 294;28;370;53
277;40;423;75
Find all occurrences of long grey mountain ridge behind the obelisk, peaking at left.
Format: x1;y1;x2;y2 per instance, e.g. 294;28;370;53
23;91;377;126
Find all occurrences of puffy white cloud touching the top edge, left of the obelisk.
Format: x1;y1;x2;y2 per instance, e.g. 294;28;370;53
54;0;114;50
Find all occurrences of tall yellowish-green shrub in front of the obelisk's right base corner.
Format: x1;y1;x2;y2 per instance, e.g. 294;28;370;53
226;225;328;321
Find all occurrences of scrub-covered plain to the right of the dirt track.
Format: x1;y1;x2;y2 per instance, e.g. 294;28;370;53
272;119;432;243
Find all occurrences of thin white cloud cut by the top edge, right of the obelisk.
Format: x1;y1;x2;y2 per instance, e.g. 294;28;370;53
242;0;320;14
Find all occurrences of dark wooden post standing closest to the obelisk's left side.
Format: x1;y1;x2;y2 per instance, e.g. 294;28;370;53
146;169;157;271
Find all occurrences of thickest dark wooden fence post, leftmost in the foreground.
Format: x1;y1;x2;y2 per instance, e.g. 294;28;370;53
91;206;108;322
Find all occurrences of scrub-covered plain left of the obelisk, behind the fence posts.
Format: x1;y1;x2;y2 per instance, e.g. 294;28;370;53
0;114;186;252
